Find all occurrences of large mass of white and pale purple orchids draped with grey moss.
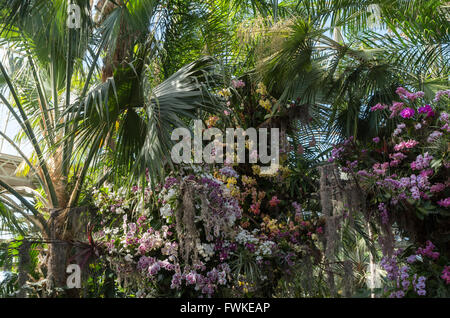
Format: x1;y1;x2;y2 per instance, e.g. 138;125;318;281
93;166;316;297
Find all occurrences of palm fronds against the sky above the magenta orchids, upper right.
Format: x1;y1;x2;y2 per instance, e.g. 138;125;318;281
251;1;449;140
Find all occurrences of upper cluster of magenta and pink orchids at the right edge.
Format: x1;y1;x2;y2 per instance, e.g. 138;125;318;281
329;87;450;223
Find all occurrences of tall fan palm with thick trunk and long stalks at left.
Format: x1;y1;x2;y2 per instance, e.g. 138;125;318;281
0;0;225;294
